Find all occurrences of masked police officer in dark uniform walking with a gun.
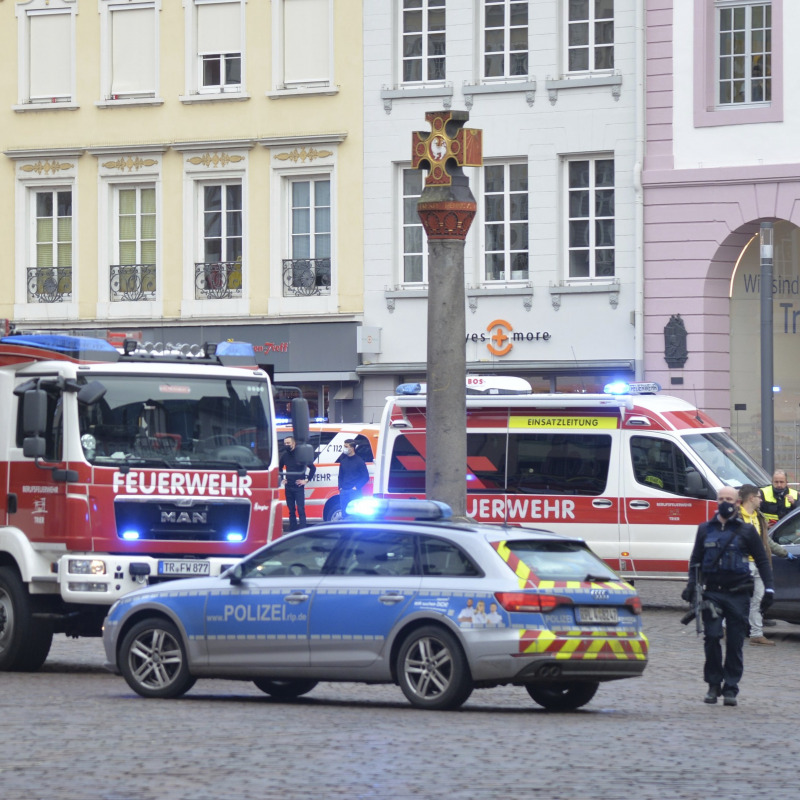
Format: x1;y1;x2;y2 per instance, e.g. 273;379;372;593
681;486;775;706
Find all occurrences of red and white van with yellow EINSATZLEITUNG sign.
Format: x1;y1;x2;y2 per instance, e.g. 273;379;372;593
374;376;770;579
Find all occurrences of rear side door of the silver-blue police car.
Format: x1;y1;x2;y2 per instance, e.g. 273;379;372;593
309;526;421;667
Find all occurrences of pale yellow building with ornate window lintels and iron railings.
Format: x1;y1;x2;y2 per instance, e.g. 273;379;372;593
0;0;363;418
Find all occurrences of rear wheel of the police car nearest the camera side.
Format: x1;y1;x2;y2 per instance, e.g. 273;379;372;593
396;625;473;709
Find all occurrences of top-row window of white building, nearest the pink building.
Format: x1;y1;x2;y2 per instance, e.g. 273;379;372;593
567;0;614;72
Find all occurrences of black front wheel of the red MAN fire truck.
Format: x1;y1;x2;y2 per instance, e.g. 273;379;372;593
0;567;53;672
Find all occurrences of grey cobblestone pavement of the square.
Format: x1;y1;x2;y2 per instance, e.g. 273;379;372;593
0;582;800;800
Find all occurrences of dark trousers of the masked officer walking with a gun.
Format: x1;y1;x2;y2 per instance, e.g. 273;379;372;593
703;589;752;697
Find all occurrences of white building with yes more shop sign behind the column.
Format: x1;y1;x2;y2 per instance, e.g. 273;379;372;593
358;0;644;421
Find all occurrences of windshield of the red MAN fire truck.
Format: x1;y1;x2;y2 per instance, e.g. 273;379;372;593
78;375;273;470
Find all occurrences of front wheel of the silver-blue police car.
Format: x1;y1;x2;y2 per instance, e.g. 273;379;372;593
118;617;196;697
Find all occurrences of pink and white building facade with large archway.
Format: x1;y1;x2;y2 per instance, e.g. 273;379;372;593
643;0;800;479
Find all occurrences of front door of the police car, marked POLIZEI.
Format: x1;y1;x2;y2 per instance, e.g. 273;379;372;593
205;530;341;672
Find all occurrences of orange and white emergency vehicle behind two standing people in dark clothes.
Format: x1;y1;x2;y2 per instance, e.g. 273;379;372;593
278;422;380;522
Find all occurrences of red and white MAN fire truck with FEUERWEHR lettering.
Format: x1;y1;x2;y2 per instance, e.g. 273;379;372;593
0;334;313;671
